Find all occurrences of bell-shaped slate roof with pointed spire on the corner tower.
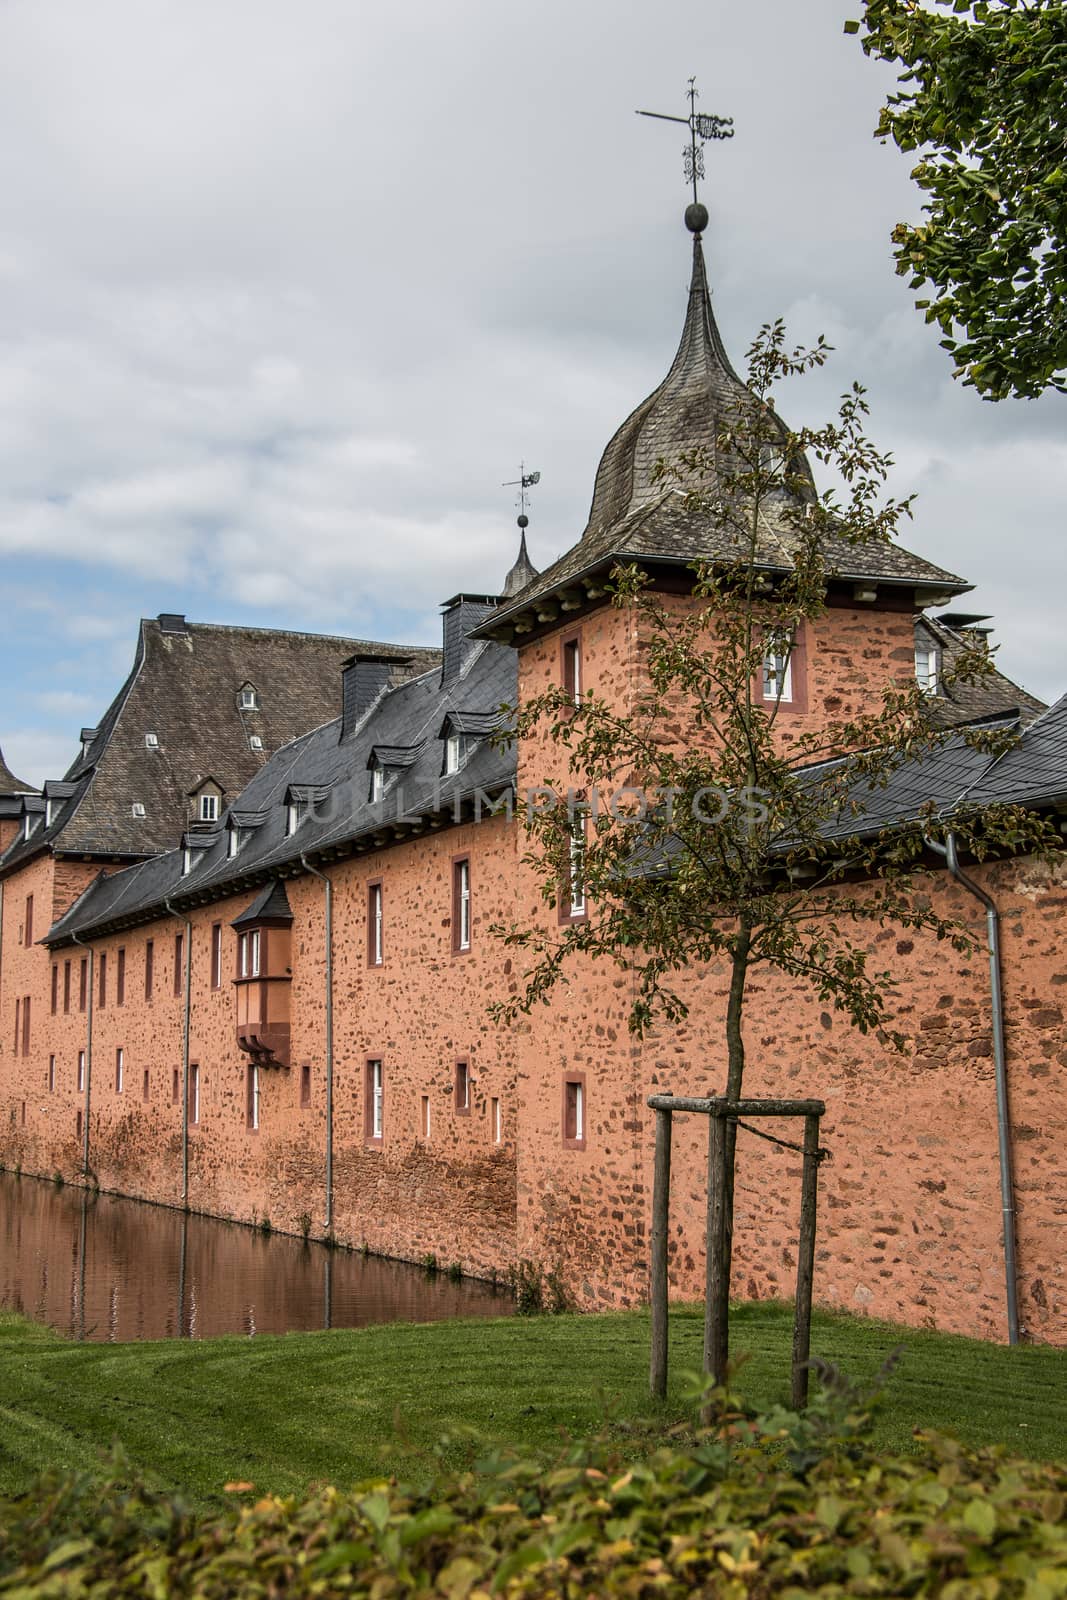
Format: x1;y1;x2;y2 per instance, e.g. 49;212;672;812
478;235;971;637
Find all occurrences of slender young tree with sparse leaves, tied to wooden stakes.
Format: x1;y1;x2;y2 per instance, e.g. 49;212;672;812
494;323;1062;1350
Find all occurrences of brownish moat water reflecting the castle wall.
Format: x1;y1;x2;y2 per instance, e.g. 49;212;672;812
0;1173;512;1341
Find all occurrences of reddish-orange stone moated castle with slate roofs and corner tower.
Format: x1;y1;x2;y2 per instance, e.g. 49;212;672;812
0;212;1067;1341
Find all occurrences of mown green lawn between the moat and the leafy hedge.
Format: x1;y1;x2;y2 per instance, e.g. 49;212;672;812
0;1302;1067;1502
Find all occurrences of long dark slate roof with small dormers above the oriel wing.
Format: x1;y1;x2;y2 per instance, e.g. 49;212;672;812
46;630;518;942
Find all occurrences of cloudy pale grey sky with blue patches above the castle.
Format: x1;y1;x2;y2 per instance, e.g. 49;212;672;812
0;0;1067;782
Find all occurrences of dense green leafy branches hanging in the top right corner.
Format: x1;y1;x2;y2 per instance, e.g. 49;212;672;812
846;0;1067;400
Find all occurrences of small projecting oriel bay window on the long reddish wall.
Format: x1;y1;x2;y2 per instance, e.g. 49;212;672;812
234;882;293;1068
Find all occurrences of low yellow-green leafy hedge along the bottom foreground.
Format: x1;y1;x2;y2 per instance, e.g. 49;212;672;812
0;1390;1067;1600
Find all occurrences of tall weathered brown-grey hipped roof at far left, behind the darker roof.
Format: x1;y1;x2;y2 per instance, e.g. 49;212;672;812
0;616;440;874
